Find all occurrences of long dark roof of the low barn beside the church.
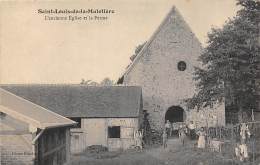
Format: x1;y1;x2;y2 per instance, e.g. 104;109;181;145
1;84;141;118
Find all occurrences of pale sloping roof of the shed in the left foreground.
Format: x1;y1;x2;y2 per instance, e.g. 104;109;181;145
0;88;75;129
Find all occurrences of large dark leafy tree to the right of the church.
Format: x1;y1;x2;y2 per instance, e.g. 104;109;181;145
186;0;260;122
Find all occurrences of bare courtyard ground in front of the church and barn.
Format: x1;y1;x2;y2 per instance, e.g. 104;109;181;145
70;139;260;165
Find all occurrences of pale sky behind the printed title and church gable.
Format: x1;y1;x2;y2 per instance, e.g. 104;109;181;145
0;0;238;84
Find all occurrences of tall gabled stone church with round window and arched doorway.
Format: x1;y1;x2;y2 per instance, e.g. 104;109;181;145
118;7;225;128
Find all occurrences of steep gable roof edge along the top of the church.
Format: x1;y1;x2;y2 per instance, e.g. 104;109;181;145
119;6;202;79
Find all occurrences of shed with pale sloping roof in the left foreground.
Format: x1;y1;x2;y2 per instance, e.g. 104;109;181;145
0;88;76;165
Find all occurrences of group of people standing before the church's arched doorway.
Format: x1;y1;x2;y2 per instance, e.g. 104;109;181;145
162;120;206;148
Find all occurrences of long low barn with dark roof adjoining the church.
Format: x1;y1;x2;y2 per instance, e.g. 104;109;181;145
2;84;142;153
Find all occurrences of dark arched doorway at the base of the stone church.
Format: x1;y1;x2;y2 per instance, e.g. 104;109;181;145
165;106;184;123
